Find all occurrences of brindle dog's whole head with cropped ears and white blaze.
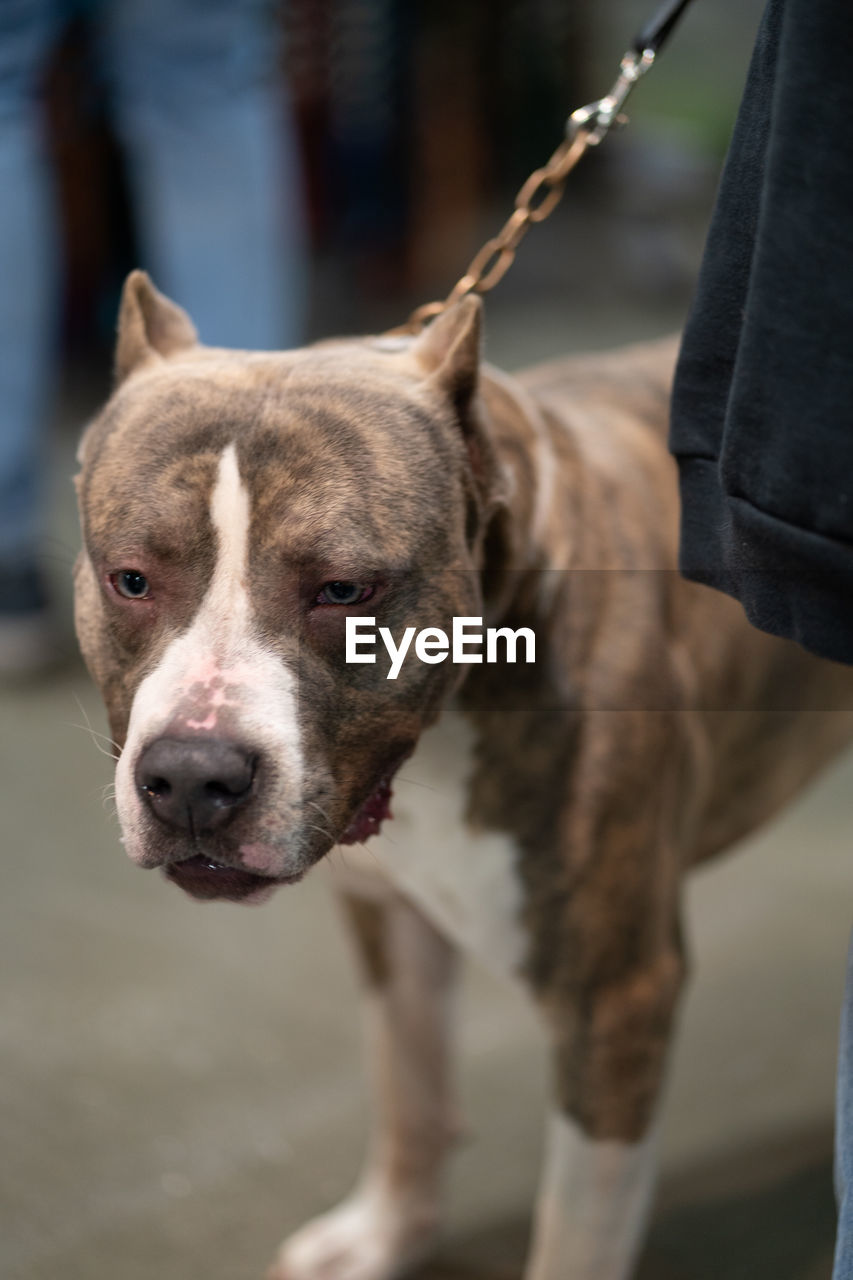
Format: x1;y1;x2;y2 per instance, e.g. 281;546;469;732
76;271;496;901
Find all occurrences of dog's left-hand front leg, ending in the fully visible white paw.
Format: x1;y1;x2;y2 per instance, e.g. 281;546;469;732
269;888;456;1280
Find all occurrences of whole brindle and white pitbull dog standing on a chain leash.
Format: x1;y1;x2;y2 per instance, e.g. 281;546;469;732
76;273;853;1280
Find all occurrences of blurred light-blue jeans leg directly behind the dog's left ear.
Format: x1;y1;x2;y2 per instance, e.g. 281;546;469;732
100;0;305;348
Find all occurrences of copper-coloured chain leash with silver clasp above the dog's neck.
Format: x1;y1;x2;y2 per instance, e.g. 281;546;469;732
389;0;689;334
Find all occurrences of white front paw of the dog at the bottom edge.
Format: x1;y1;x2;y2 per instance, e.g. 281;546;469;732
266;1192;437;1280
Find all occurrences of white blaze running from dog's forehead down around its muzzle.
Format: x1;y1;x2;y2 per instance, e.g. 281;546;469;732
115;443;302;874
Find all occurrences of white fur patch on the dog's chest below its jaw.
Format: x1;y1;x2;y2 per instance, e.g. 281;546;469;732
346;712;525;974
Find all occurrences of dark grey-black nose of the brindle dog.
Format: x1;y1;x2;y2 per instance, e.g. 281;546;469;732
136;737;255;835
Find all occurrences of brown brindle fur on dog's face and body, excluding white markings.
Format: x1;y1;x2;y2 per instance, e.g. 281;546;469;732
71;274;853;1269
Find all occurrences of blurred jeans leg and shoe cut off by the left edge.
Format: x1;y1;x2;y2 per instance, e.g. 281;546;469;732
0;0;63;675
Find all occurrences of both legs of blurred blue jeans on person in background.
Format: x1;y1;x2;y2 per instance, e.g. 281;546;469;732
0;0;304;564
